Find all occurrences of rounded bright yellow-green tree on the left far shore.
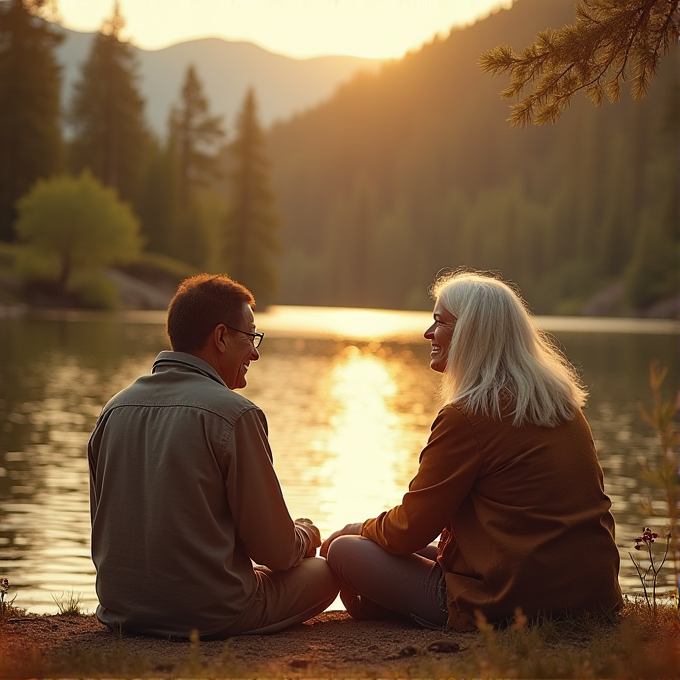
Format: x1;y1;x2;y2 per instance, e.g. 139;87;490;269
16;171;141;290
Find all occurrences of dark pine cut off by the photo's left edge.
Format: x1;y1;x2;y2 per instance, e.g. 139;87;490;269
0;0;63;241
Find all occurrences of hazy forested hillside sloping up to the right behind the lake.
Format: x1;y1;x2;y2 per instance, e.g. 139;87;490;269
267;0;680;313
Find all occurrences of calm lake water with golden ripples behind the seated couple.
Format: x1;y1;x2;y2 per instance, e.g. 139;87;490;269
0;307;679;612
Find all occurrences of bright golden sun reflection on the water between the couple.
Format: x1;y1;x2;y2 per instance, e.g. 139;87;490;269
312;346;412;532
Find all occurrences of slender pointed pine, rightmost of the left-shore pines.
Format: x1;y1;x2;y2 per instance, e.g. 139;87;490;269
224;90;281;303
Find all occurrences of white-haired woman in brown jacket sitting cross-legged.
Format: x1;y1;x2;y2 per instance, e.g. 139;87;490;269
321;272;622;630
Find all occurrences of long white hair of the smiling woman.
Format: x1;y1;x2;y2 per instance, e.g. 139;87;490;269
430;271;587;427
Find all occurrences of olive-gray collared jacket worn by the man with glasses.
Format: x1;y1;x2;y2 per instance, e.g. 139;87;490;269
88;352;311;636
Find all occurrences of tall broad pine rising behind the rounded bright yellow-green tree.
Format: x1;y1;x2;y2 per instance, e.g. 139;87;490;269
69;2;149;202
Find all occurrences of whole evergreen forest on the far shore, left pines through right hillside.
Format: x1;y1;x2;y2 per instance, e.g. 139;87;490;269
0;0;680;316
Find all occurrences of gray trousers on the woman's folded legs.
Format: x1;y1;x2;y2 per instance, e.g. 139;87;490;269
327;536;448;628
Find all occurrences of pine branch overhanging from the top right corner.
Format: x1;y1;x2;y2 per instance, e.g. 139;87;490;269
480;0;680;125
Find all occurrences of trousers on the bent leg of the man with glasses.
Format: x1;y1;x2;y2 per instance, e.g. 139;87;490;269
205;557;338;640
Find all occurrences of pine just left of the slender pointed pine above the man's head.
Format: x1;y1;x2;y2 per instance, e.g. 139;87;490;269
168;65;224;266
